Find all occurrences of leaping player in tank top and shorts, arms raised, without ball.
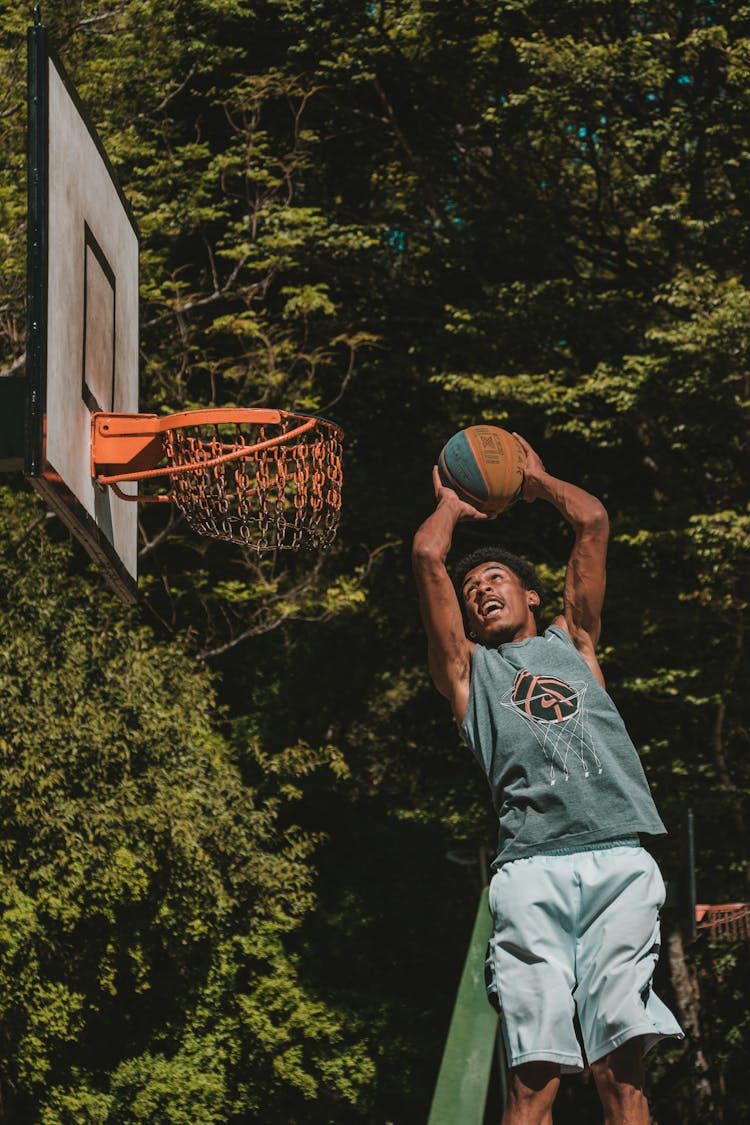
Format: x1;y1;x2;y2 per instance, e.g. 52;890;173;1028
414;434;683;1125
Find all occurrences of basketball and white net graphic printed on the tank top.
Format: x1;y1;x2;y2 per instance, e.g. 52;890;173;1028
500;668;602;785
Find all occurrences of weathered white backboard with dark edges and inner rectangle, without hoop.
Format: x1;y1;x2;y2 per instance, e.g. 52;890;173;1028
24;25;138;601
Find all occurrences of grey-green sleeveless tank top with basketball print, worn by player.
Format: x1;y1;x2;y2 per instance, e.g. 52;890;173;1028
461;626;666;865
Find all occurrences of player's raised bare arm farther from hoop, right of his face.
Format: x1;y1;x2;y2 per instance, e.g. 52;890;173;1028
516;434;609;684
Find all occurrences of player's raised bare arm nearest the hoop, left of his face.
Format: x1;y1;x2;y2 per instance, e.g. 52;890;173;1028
412;469;486;722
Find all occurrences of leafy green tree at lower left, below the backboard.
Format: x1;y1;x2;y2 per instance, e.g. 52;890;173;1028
0;489;372;1125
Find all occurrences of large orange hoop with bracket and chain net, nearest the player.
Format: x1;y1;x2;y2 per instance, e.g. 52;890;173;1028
91;407;343;551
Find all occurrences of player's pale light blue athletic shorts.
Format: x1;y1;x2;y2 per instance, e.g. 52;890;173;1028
487;845;683;1072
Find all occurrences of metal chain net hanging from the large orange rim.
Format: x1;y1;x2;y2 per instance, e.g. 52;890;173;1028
163;414;342;552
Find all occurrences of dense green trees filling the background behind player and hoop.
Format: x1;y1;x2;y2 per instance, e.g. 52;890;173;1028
0;0;750;1125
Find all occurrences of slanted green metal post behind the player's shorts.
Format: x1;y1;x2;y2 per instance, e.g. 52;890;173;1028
427;888;499;1125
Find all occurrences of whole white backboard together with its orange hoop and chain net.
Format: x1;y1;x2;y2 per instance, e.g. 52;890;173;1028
0;13;343;602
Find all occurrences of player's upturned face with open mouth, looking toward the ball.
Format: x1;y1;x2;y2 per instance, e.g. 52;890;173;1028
461;563;539;646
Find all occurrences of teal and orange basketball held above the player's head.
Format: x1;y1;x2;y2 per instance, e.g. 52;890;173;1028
437;425;526;515
